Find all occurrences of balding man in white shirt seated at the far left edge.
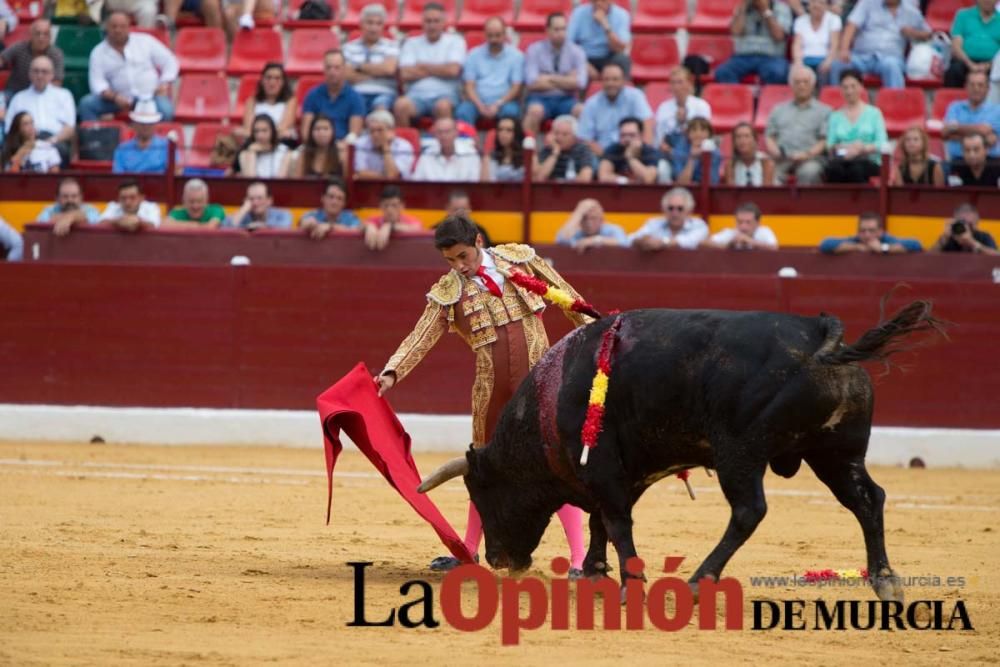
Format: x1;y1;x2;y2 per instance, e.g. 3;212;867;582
6;56;76;167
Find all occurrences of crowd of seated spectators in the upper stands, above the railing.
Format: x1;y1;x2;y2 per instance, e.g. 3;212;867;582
0;0;1000;186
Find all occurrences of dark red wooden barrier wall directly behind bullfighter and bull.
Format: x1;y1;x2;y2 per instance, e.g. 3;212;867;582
0;263;1000;428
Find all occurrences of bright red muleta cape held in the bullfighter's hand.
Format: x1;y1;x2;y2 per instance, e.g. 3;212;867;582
316;362;472;563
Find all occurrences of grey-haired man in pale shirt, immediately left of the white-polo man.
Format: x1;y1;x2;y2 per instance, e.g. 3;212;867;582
344;2;399;113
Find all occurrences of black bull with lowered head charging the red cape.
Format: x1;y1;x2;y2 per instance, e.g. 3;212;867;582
421;301;939;600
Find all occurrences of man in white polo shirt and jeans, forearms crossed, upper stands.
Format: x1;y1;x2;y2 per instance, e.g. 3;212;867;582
393;2;465;127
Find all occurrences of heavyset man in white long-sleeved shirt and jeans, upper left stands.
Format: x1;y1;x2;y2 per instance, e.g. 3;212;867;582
79;12;180;121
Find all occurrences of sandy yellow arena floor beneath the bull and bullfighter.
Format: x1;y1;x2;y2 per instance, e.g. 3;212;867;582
0;442;1000;666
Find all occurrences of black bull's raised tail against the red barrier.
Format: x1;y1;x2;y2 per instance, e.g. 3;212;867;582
813;295;948;365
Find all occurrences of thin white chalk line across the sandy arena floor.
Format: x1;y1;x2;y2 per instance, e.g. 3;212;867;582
0;459;1000;512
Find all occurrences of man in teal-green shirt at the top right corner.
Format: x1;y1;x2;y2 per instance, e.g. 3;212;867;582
944;0;1000;88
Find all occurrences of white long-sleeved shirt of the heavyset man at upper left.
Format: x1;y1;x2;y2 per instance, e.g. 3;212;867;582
90;32;180;98
